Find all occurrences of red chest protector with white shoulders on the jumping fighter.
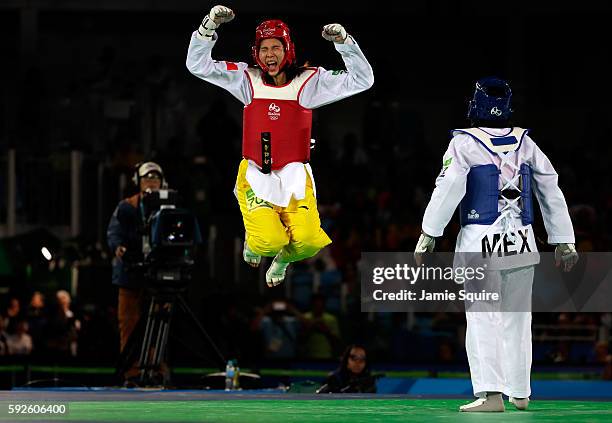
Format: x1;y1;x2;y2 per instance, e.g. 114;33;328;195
242;68;317;173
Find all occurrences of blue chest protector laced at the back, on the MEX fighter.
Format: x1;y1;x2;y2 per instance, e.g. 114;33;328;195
453;128;533;226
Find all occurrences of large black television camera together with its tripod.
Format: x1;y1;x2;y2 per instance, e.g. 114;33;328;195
117;189;225;386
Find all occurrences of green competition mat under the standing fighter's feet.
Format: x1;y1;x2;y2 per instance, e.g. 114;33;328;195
0;390;612;423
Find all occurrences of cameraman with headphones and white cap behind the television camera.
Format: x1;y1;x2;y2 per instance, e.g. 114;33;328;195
106;162;165;386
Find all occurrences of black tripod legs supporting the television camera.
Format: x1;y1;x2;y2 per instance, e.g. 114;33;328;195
117;286;225;386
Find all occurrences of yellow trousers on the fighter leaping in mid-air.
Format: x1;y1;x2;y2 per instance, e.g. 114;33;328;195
236;159;332;262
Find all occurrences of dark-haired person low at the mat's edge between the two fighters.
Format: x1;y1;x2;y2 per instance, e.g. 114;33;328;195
317;344;376;394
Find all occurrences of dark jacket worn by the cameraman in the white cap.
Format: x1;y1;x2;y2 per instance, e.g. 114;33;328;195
106;194;144;288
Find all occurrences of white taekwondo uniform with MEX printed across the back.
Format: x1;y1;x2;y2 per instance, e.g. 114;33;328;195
422;128;574;398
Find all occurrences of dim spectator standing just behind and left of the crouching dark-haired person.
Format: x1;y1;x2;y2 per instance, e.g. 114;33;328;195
302;294;340;360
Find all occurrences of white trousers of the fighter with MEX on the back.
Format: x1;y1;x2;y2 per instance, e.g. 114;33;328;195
465;266;534;398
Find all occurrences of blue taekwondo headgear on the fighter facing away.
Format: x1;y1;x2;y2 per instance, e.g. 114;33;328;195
468;77;512;121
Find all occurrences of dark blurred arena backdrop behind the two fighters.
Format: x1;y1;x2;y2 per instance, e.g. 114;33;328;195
0;0;612;382
